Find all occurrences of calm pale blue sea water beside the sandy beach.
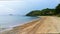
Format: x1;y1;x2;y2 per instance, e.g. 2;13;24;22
0;16;38;31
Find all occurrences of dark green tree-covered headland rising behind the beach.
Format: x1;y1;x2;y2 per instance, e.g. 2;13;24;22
26;4;60;16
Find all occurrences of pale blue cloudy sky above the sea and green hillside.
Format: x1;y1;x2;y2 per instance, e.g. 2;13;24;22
0;0;60;15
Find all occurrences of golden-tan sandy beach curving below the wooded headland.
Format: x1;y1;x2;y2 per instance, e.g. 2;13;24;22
1;16;60;34
